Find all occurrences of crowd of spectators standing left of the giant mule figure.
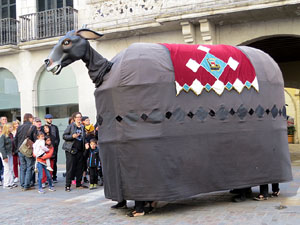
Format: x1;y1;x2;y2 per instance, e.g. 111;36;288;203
0;112;103;194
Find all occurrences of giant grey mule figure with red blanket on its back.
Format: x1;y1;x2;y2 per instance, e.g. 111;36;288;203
45;29;292;201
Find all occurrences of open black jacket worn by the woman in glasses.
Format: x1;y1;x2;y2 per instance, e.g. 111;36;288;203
62;123;85;152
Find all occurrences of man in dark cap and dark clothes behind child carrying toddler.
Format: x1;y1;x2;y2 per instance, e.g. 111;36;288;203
45;114;60;183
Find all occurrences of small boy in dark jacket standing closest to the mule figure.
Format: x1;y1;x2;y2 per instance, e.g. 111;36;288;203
85;139;99;190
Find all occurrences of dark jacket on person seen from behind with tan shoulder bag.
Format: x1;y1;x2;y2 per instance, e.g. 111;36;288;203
15;121;36;151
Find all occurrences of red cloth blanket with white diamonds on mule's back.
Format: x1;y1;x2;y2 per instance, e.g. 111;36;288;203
162;44;259;95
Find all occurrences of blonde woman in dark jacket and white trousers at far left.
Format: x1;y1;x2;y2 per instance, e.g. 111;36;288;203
0;123;18;189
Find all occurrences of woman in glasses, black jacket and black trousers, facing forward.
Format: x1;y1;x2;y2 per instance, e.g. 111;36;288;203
62;112;88;192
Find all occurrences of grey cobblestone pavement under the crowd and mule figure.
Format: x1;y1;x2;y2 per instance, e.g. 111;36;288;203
0;145;300;225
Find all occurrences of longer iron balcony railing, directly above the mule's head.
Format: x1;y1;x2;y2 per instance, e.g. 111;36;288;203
20;7;78;42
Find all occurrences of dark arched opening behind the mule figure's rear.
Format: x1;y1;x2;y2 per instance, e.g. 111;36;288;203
243;35;300;143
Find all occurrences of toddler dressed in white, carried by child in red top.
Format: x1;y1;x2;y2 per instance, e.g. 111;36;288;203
32;131;53;172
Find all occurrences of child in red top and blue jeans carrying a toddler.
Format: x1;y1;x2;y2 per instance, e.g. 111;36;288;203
33;134;55;194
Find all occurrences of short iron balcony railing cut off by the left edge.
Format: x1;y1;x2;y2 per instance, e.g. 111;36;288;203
0;18;19;46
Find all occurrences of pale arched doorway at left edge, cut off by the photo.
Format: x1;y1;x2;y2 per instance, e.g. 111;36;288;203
0;68;21;121
